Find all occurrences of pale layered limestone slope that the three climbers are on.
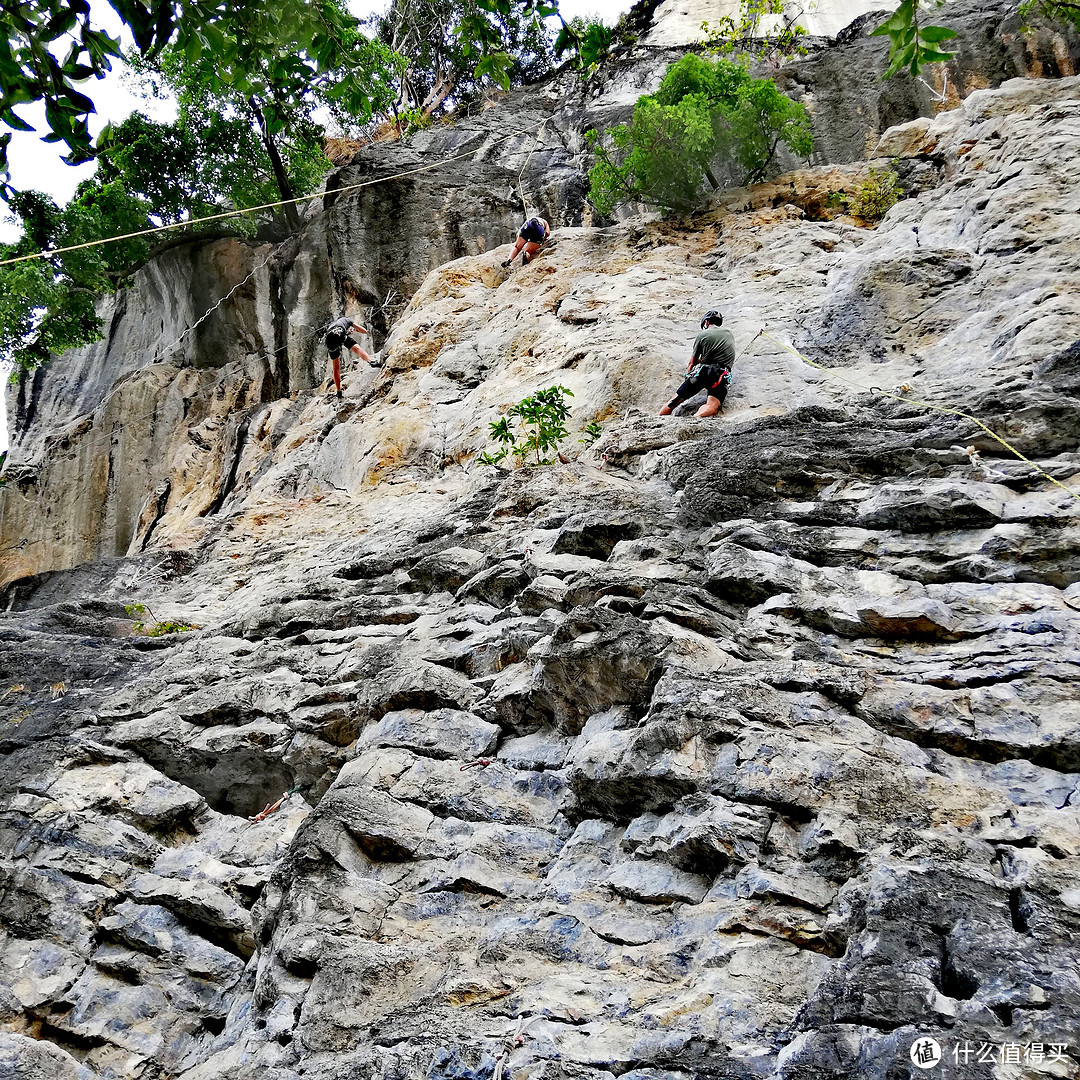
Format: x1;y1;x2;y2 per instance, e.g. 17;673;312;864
0;8;1080;1080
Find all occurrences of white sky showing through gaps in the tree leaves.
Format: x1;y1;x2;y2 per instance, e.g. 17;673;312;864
0;0;632;453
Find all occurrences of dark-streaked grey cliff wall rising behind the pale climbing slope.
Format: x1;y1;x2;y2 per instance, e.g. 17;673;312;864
0;0;1080;583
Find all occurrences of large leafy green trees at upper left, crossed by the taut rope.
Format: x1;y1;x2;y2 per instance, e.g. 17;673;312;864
0;0;402;369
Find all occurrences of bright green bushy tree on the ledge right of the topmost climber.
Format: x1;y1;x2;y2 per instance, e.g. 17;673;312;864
589;54;813;214
